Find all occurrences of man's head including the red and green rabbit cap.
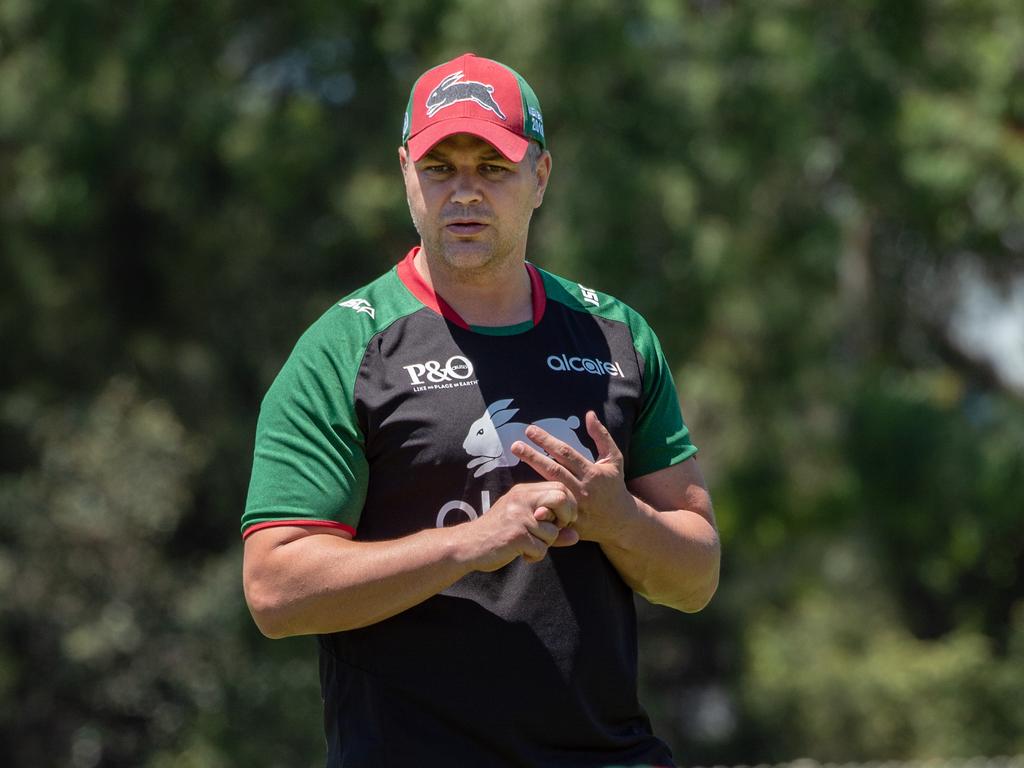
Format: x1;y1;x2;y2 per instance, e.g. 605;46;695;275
398;53;551;274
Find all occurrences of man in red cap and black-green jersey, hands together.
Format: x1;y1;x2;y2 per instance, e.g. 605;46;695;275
243;53;719;766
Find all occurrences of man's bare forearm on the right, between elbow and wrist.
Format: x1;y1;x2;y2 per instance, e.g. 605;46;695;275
600;497;721;612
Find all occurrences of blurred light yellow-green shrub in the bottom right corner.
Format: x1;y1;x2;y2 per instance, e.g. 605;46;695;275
744;590;1024;761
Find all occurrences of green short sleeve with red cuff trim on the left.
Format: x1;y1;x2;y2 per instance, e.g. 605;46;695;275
242;318;369;537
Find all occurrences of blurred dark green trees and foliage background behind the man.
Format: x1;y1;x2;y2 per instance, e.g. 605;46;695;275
0;0;1024;768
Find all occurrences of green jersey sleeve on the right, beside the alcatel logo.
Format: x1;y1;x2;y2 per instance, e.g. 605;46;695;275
626;311;697;479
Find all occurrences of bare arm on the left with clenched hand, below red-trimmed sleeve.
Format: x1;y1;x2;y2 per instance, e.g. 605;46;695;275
243;482;579;638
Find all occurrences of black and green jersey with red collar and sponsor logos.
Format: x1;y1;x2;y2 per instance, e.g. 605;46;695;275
242;249;696;766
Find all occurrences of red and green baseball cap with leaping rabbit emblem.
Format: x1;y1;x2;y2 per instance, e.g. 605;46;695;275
401;53;545;163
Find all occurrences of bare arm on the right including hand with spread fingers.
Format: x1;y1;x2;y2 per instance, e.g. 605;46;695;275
512;412;721;612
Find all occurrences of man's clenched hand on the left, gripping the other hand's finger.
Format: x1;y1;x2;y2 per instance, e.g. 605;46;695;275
457;481;580;570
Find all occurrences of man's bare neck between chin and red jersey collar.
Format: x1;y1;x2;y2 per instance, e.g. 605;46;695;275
413;248;534;327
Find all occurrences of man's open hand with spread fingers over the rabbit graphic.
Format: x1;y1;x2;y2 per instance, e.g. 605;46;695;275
512;411;636;543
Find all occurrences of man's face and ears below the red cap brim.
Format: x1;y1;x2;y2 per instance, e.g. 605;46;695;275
398;133;551;271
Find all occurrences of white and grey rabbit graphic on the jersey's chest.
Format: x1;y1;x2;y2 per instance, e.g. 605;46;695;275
462;397;594;477
